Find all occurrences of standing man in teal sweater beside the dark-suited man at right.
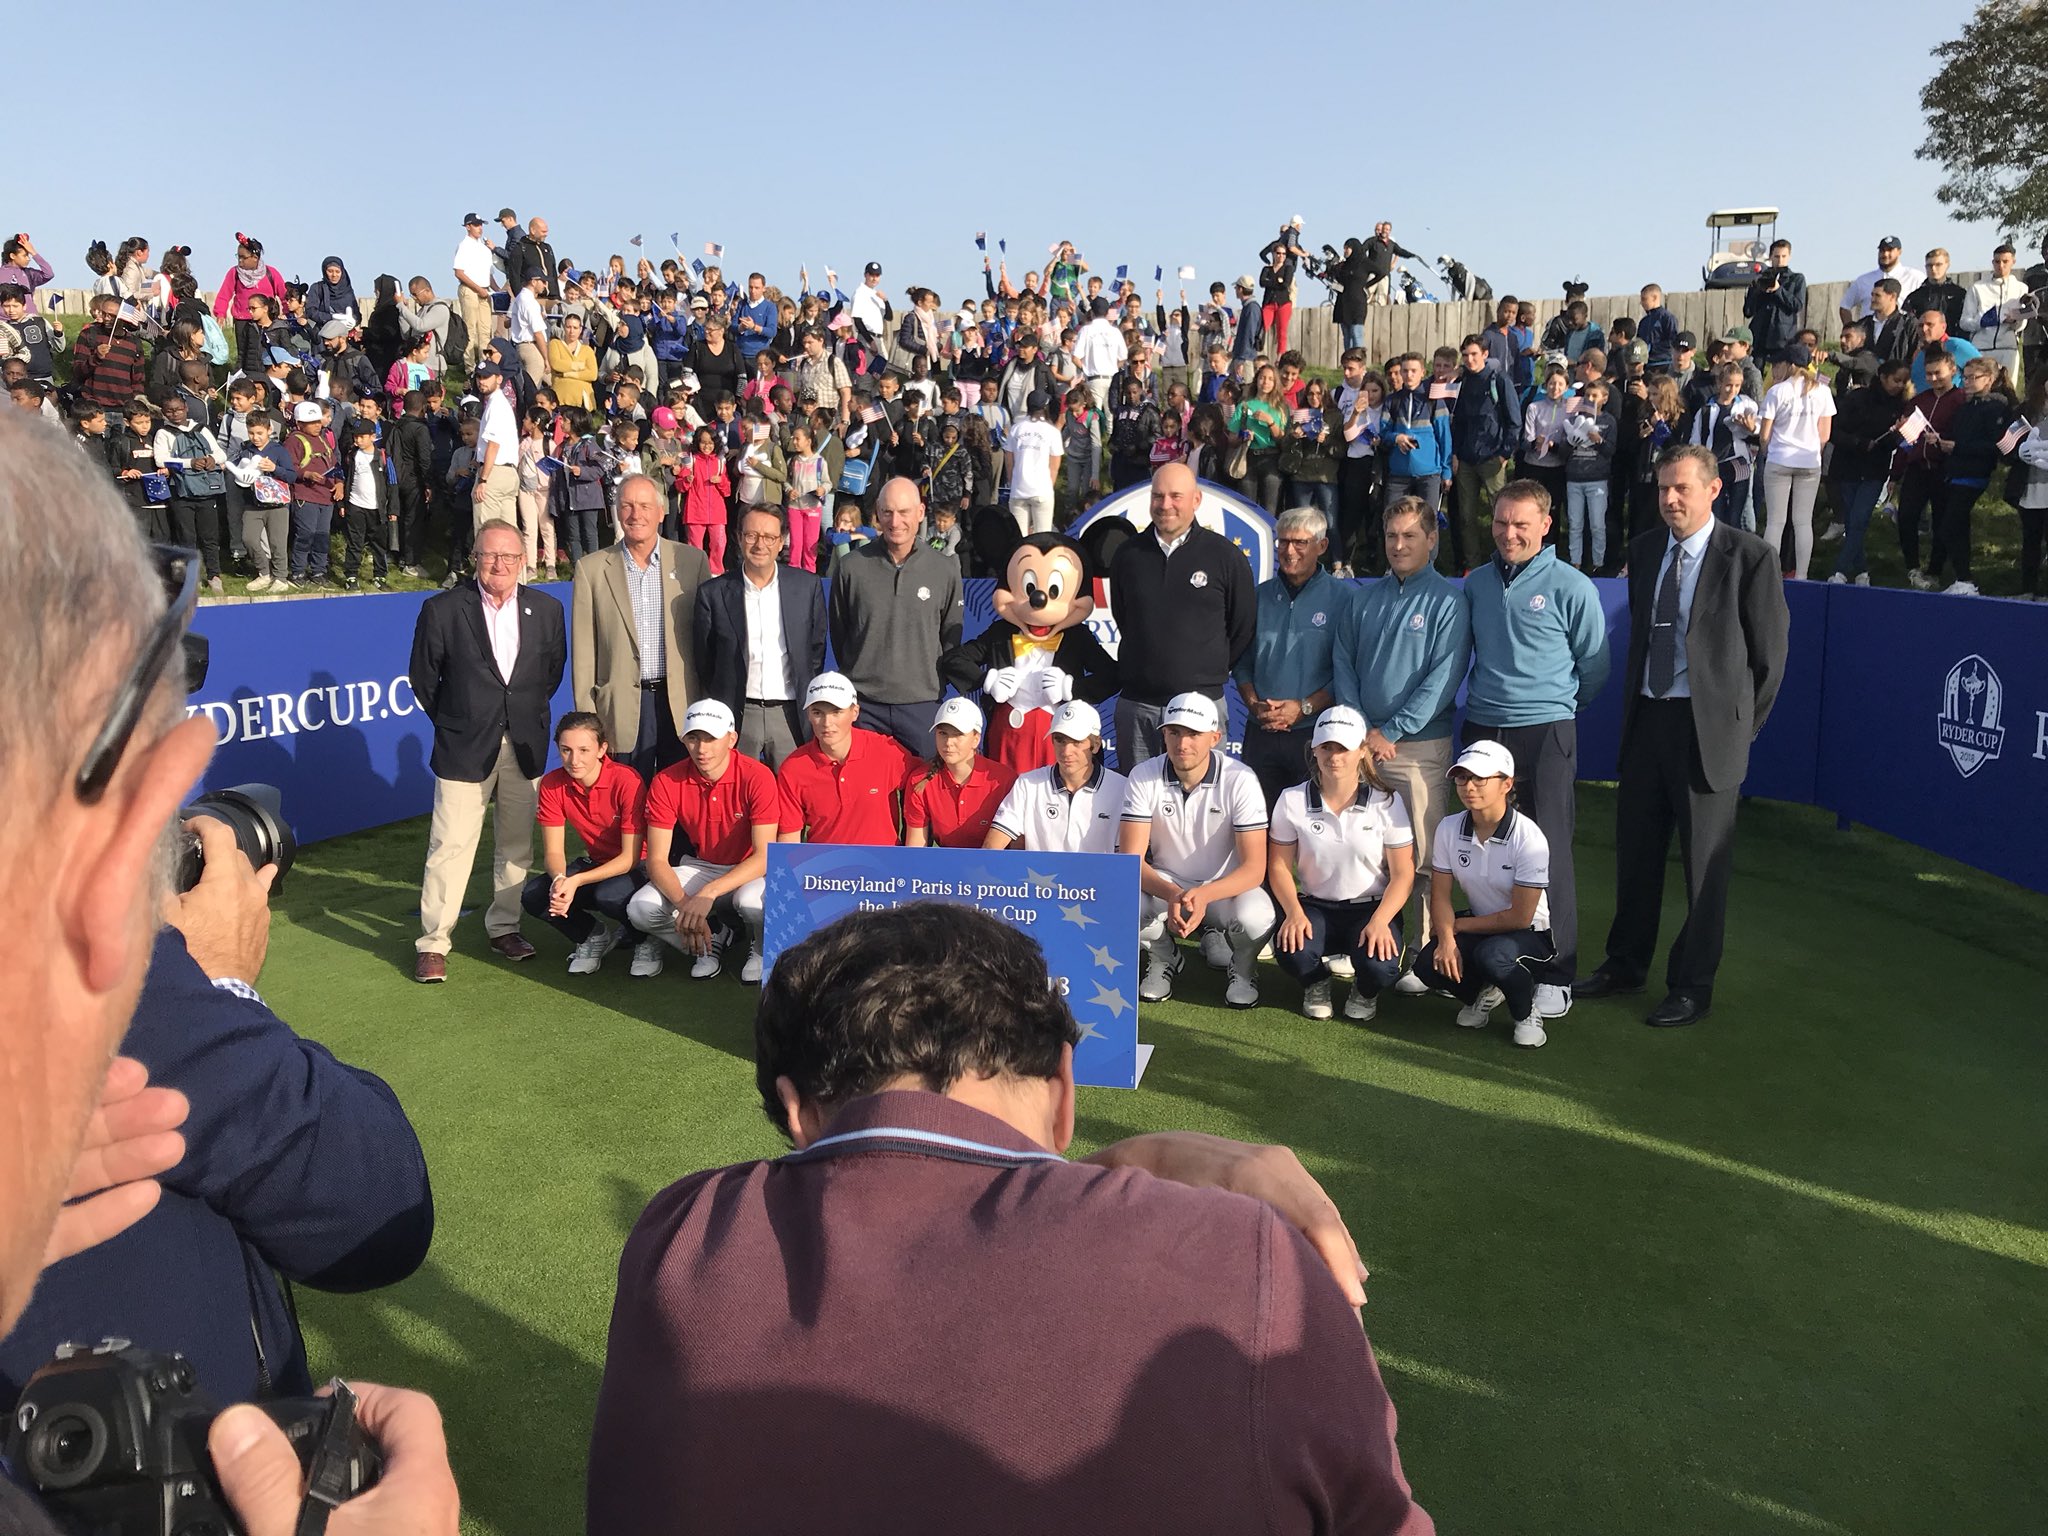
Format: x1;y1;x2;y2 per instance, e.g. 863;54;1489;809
1464;479;1610;1018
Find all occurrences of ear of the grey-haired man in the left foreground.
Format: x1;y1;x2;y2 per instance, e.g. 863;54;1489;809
53;715;215;993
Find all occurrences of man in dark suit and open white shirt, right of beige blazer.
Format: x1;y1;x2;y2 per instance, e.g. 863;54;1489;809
694;506;825;768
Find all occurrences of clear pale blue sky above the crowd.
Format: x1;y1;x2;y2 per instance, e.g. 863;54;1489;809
0;0;1999;313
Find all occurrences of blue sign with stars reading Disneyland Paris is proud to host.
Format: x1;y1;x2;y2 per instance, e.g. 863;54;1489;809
762;842;1151;1087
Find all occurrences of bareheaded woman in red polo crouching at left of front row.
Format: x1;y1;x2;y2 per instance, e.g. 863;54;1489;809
520;709;647;977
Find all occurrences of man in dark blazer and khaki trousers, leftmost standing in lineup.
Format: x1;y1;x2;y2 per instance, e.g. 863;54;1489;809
410;518;569;981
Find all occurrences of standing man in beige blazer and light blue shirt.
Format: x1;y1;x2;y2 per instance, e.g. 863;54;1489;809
569;475;711;780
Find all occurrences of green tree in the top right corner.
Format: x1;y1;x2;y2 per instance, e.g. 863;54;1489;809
1919;0;2048;236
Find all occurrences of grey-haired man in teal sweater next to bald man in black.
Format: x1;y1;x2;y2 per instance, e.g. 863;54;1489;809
1231;506;1350;811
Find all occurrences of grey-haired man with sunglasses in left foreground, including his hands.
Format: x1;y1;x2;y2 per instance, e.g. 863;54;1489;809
0;414;457;1536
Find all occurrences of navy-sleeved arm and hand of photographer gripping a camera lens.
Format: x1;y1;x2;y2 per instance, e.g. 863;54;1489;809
0;815;434;1403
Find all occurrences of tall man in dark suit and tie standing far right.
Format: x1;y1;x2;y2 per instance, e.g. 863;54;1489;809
1577;444;1790;1026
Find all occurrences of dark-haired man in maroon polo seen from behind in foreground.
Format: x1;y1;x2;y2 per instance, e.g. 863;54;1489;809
586;903;1434;1536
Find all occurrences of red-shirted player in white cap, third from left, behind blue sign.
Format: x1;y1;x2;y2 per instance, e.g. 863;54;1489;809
776;672;918;848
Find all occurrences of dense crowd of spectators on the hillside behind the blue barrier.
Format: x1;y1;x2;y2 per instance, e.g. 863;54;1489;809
0;219;2048;596
